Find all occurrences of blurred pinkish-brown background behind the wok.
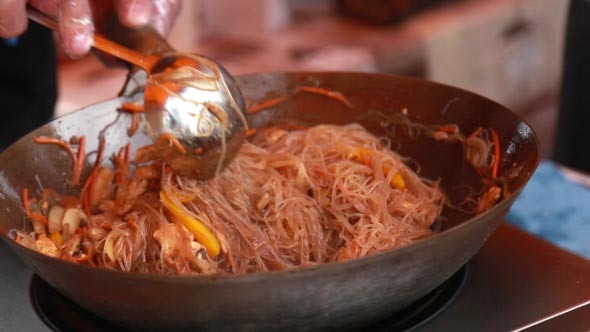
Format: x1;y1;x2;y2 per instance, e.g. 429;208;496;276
57;0;568;160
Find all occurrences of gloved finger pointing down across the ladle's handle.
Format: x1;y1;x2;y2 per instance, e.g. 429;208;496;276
58;0;94;58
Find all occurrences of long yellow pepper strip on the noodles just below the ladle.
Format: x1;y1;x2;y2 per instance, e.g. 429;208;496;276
160;191;221;257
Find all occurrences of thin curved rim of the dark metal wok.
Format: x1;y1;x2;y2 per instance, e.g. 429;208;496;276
0;71;541;285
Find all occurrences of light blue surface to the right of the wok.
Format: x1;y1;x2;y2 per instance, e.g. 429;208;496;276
506;161;590;258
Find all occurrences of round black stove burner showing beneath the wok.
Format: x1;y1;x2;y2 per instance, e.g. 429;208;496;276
29;266;468;332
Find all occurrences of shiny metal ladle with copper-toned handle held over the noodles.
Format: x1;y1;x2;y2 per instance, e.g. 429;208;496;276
27;6;248;180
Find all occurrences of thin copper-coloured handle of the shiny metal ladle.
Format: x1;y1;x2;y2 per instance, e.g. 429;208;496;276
27;5;160;72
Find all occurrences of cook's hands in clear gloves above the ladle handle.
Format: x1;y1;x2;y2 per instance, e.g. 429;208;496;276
0;0;181;58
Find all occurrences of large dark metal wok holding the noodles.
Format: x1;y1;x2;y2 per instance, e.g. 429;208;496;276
0;73;539;331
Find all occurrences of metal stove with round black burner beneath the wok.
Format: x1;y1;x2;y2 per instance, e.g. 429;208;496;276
0;223;590;332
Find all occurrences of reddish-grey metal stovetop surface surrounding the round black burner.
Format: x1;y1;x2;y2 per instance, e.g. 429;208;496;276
0;224;590;332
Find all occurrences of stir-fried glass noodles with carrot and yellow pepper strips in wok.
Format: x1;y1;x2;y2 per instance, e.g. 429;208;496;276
12;87;501;274
